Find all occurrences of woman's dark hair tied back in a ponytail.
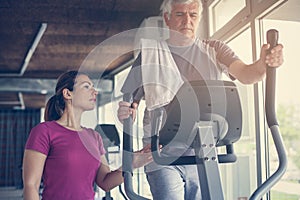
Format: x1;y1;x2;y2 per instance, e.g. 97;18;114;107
44;71;85;121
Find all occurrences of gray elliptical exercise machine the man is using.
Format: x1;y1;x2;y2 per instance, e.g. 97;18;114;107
123;29;287;200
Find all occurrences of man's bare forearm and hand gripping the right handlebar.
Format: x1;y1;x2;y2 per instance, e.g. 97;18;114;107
229;44;283;84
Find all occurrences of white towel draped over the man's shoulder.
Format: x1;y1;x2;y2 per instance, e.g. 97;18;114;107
141;39;183;110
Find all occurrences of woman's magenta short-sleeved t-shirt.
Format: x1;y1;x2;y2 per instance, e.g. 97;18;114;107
25;121;106;200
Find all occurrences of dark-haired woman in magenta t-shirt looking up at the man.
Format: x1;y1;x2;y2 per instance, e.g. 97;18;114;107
23;71;152;200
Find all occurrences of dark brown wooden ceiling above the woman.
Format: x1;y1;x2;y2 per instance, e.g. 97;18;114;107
0;0;162;109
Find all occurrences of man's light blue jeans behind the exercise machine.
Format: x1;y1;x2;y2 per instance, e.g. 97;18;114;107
146;165;201;200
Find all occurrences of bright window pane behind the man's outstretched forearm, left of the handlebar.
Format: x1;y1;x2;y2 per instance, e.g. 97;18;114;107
219;29;256;199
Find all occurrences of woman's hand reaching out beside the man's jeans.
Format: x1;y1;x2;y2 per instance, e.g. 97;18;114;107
132;144;153;169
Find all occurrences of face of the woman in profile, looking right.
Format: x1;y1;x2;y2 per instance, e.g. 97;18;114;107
72;75;98;111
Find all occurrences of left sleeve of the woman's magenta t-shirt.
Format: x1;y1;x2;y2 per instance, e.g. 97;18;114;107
25;124;50;155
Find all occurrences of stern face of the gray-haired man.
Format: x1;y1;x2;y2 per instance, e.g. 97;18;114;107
164;2;199;39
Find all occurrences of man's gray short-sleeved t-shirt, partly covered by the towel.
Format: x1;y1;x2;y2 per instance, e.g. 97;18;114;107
121;39;239;171
